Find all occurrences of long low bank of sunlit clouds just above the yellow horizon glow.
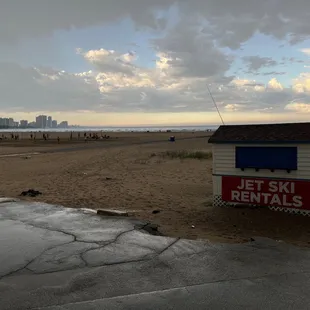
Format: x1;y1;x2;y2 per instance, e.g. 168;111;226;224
0;49;310;113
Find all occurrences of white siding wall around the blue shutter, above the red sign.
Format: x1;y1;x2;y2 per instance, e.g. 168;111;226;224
212;144;310;181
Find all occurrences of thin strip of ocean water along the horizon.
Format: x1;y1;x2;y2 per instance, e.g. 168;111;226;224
0;126;219;132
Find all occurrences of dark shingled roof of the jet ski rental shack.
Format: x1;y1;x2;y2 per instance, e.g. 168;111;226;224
209;123;310;143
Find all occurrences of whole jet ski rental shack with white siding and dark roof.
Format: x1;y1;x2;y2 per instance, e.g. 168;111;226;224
209;123;310;215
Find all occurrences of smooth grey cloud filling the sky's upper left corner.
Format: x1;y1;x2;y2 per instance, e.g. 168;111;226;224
0;0;171;43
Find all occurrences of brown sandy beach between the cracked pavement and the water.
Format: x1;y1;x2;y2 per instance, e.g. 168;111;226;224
0;132;310;246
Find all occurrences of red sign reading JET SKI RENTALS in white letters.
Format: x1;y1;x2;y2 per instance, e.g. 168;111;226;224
222;176;310;210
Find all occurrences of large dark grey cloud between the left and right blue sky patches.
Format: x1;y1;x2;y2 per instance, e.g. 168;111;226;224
152;18;233;78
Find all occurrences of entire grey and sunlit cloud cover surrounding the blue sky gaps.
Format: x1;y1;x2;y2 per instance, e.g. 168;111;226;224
0;0;310;118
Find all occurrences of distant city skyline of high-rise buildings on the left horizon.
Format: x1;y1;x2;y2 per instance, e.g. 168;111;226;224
0;114;69;129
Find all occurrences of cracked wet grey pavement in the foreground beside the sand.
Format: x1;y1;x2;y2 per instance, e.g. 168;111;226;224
0;199;310;310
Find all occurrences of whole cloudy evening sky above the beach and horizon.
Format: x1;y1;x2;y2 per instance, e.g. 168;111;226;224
0;0;310;126
